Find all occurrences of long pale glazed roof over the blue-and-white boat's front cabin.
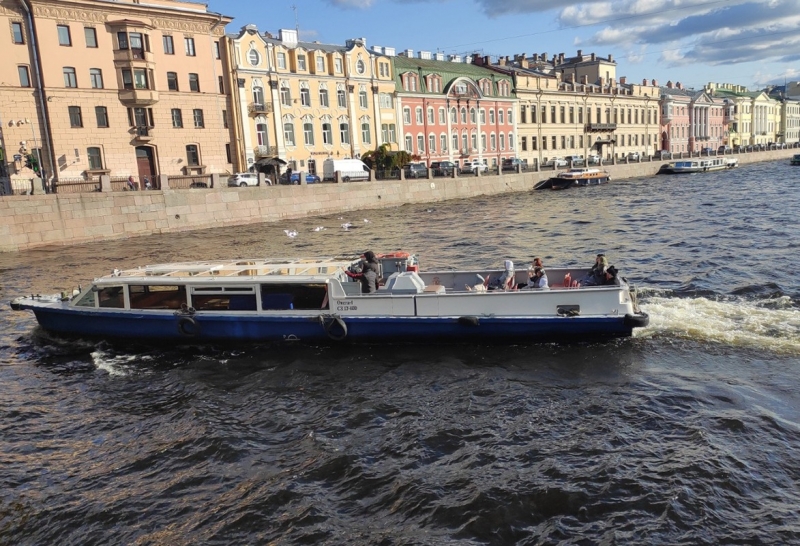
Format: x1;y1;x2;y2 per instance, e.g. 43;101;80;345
95;256;361;282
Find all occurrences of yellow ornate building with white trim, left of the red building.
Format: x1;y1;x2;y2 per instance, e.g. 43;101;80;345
228;25;396;175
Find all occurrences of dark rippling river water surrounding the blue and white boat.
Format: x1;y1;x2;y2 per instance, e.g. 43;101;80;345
0;162;800;545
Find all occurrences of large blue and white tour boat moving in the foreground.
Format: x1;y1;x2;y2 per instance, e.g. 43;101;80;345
11;252;648;343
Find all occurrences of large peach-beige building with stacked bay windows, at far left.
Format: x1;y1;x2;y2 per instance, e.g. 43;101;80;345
0;0;231;186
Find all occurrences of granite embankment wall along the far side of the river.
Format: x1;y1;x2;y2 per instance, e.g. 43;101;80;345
0;149;797;252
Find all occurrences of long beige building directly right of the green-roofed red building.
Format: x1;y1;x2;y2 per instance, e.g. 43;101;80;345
483;51;659;164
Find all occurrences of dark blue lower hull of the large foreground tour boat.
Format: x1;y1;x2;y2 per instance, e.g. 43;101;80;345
32;308;647;343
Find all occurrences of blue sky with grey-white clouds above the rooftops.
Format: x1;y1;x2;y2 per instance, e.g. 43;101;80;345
206;0;800;90
